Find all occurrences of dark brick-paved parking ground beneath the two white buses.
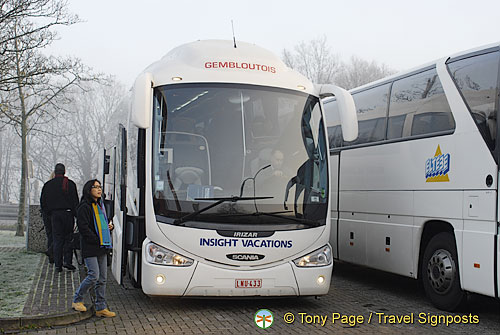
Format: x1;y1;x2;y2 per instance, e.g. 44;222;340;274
17;264;500;334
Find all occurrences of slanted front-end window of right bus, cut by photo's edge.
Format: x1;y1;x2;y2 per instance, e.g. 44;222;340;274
448;52;499;150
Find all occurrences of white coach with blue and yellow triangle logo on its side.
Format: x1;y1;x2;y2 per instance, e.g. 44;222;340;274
324;44;500;310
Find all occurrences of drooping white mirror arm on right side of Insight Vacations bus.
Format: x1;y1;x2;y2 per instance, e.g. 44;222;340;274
319;84;358;142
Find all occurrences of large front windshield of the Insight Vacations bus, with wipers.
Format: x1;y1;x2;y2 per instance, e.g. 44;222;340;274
152;84;328;229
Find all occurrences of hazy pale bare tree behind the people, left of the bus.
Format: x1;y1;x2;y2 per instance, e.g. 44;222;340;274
25;77;127;207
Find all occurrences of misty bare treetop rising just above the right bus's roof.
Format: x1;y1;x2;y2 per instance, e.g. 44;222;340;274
335;56;395;90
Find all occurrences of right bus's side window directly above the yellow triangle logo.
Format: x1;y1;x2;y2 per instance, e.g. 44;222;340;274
387;69;455;139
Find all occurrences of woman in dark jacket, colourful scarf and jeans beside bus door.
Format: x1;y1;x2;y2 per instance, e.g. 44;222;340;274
71;179;116;318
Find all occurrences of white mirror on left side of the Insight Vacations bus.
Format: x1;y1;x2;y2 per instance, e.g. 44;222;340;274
131;72;153;129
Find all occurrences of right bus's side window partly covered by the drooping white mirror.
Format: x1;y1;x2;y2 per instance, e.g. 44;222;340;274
345;84;390;145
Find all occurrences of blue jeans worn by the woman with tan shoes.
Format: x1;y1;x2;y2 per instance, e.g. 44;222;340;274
73;254;108;311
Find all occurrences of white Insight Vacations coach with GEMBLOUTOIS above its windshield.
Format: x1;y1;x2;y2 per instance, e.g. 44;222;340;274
104;40;357;296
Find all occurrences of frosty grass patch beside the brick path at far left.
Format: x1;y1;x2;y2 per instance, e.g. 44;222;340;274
0;251;40;317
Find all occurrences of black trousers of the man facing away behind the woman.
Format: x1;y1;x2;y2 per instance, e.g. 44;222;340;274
52;210;74;268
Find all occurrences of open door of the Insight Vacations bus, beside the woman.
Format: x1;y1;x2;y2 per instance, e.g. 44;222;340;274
111;124;127;285
